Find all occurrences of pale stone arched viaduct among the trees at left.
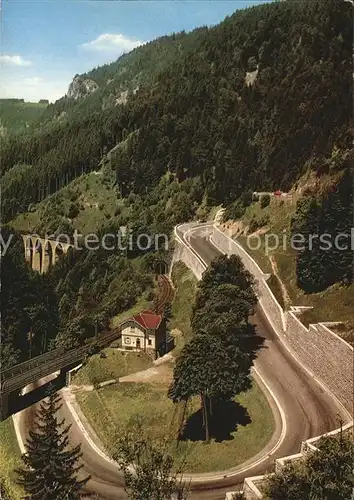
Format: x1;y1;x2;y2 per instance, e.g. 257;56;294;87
21;234;74;273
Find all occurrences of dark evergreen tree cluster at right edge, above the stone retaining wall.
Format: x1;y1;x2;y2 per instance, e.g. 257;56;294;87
292;169;354;293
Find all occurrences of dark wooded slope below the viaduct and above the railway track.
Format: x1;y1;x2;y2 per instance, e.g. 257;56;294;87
0;226;154;370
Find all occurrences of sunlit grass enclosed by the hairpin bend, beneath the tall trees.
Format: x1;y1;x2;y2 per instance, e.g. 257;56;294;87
78;383;274;472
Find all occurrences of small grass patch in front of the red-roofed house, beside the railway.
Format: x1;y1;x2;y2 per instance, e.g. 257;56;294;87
73;348;152;385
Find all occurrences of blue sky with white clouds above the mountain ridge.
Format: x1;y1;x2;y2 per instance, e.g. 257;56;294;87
0;0;272;102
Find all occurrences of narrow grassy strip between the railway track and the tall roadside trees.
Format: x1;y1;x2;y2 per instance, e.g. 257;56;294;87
170;262;198;354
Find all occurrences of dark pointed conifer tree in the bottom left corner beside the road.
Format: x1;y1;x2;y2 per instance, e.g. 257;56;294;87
16;393;89;500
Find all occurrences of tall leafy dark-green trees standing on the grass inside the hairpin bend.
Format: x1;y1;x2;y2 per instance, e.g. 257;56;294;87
169;255;261;441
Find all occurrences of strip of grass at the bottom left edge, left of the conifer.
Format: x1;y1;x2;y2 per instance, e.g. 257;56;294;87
0;418;23;500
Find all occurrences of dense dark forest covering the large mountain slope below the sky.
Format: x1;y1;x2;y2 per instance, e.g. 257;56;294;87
2;0;352;223
